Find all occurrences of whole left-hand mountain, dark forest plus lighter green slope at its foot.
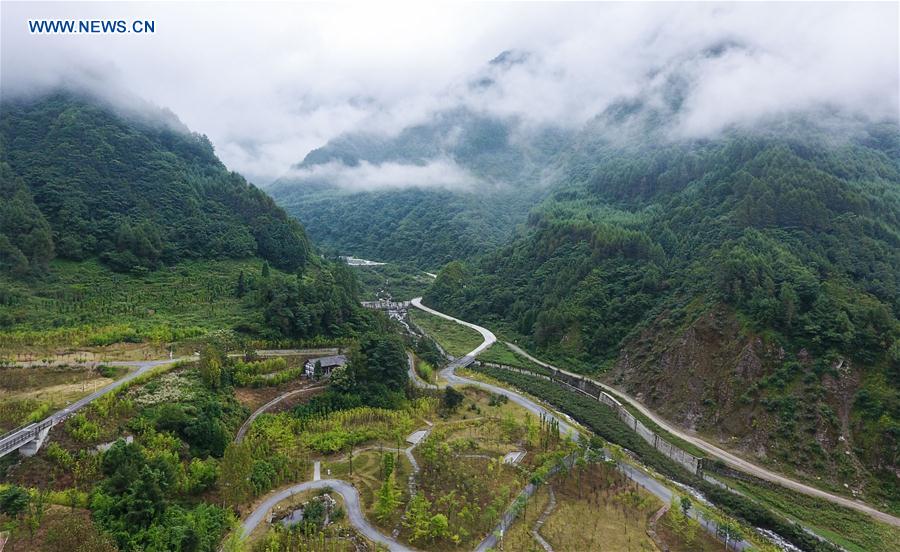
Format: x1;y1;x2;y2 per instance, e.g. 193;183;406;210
0;92;361;344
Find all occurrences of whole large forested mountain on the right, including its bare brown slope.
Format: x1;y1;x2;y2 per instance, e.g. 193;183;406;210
426;115;900;505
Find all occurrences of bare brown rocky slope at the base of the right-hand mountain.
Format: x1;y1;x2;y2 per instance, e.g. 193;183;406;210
606;306;865;494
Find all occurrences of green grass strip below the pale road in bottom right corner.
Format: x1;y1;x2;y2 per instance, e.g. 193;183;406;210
717;476;900;552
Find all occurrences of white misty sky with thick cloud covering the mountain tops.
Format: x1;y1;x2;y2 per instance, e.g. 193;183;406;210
0;2;900;184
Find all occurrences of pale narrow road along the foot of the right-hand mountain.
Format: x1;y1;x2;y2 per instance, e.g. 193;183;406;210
506;342;900;527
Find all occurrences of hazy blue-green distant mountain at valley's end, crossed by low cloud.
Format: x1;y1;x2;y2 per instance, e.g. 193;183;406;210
267;52;572;268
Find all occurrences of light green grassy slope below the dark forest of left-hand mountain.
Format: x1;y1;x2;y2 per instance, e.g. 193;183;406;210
0;261;260;355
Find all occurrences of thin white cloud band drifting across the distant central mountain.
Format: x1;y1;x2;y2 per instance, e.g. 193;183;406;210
286;159;483;192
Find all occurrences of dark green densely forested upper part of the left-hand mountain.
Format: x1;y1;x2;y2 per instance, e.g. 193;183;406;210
0;93;311;275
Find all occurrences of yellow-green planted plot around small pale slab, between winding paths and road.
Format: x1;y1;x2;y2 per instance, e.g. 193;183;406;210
400;389;574;550
